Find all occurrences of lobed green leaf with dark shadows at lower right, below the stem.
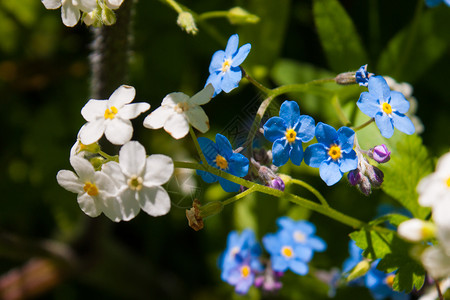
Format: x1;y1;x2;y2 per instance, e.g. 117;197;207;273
350;228;425;293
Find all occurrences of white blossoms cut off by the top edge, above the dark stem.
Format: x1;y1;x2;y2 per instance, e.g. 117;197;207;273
41;0;123;27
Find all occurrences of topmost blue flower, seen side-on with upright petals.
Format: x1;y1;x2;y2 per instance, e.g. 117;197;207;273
205;34;251;96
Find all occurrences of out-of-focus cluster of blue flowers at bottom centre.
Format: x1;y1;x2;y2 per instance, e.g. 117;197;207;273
218;217;327;294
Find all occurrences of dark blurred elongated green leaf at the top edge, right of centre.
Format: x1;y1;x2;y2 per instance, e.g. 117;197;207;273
313;0;367;72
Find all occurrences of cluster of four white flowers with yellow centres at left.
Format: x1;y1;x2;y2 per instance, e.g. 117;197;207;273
57;85;214;222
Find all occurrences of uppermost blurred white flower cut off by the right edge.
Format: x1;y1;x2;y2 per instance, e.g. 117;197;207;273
417;153;450;206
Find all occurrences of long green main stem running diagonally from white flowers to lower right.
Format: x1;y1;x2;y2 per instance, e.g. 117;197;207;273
174;161;368;228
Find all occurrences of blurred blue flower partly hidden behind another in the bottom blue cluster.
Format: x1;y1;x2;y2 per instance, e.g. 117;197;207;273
277;217;327;252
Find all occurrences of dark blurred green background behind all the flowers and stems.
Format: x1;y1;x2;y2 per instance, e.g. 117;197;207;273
0;0;450;299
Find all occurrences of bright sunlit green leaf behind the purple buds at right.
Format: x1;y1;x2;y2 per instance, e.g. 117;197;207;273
380;135;433;219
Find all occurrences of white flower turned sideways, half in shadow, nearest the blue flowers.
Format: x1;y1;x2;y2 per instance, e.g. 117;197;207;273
144;84;214;139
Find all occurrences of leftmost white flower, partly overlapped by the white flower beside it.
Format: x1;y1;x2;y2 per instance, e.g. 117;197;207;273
56;156;120;222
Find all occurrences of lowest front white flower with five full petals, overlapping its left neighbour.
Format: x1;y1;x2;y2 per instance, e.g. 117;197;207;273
103;141;174;221
